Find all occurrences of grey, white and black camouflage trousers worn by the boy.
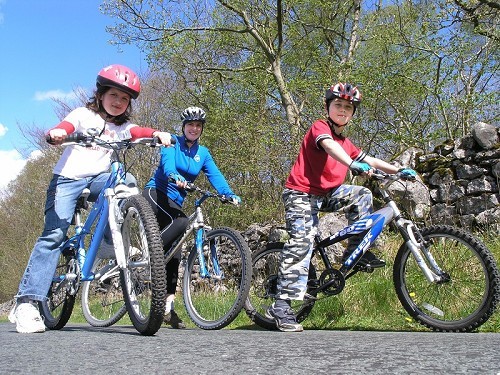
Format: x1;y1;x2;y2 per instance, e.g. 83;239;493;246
276;185;373;300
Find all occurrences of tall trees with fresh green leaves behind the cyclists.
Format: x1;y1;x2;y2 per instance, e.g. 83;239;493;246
99;0;500;231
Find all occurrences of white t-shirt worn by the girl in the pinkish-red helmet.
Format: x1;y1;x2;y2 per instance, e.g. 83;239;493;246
53;107;138;180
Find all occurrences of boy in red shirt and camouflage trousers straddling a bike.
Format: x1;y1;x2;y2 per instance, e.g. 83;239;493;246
267;83;415;332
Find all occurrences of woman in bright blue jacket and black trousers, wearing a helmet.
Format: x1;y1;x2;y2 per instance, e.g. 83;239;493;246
142;107;241;328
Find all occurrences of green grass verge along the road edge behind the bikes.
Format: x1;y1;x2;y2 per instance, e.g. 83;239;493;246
0;234;500;332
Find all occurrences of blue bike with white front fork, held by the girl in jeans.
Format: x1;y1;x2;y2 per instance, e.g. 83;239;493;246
39;131;166;335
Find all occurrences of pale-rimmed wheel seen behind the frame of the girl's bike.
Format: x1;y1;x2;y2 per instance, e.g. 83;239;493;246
82;258;127;327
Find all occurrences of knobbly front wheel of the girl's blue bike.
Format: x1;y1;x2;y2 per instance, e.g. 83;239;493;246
120;195;167;336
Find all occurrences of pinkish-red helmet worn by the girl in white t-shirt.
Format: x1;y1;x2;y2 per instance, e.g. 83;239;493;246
96;64;141;99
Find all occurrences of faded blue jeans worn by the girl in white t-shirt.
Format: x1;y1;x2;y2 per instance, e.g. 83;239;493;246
15;173;136;301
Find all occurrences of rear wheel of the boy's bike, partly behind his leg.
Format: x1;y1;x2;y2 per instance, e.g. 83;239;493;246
244;242;316;330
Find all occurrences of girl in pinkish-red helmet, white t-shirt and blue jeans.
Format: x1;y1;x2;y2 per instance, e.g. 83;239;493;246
9;65;171;333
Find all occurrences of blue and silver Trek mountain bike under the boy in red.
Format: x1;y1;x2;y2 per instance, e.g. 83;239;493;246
245;171;500;332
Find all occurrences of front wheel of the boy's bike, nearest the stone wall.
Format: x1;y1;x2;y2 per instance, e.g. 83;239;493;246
393;225;500;332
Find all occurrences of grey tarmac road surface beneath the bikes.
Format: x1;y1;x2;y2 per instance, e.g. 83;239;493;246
0;323;500;375
